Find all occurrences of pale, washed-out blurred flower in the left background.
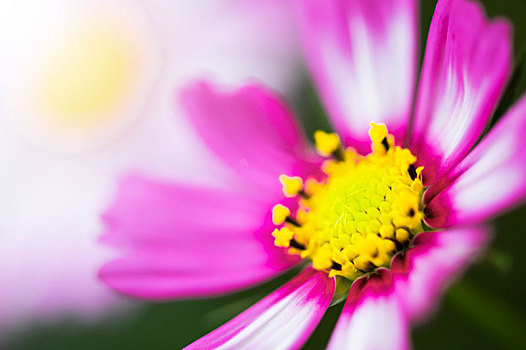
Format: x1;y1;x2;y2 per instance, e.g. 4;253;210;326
0;0;299;334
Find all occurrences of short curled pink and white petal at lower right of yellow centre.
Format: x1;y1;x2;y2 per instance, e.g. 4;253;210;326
392;227;491;320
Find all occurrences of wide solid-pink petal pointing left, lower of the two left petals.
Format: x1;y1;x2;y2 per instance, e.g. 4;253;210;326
99;176;297;299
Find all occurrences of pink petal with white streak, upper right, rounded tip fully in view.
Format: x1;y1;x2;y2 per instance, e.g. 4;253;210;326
411;0;512;183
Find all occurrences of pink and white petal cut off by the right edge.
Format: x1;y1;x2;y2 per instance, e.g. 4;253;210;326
426;96;526;227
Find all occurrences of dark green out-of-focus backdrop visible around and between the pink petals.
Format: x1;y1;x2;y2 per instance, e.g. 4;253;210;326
9;0;526;350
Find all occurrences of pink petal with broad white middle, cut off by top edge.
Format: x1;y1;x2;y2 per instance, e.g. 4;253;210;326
298;0;418;151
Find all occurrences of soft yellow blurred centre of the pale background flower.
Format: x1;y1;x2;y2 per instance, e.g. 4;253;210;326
40;28;137;127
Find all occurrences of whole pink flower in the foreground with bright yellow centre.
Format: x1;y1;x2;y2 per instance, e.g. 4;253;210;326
100;0;526;349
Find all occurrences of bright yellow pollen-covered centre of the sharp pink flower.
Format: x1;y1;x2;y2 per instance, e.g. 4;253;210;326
272;123;423;280
